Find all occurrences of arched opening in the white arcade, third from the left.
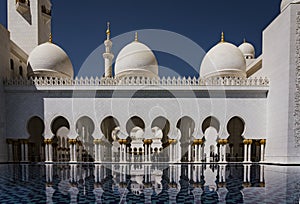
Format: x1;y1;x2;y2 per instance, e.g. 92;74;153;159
76;116;95;162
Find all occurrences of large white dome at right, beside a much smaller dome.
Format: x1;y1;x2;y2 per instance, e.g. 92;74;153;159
200;42;246;78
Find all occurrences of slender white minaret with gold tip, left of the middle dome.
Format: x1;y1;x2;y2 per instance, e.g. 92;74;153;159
103;22;114;78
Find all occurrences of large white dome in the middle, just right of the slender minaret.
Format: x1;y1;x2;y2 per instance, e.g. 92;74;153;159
115;41;158;78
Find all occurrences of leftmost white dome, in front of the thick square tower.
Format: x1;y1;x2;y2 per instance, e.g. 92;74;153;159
27;42;74;78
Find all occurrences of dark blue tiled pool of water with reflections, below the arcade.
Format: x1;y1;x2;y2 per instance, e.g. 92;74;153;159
0;164;300;203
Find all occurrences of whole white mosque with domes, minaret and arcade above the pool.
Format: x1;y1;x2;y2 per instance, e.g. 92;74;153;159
0;0;300;164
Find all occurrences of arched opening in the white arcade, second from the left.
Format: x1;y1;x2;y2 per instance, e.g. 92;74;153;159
51;116;70;161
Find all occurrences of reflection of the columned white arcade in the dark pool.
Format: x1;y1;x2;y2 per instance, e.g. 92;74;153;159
45;164;265;203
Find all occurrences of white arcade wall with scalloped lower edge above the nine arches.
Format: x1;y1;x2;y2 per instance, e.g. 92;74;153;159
6;90;266;145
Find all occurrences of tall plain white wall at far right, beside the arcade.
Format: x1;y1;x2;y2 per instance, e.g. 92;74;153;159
262;4;300;162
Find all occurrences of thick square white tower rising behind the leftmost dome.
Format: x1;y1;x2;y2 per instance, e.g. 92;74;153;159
7;0;51;54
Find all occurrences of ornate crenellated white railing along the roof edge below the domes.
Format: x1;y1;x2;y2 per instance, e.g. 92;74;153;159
3;77;269;87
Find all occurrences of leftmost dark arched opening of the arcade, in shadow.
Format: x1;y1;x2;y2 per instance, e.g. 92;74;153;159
27;116;45;162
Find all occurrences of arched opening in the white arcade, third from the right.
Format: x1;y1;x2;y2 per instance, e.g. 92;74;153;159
177;116;195;162
